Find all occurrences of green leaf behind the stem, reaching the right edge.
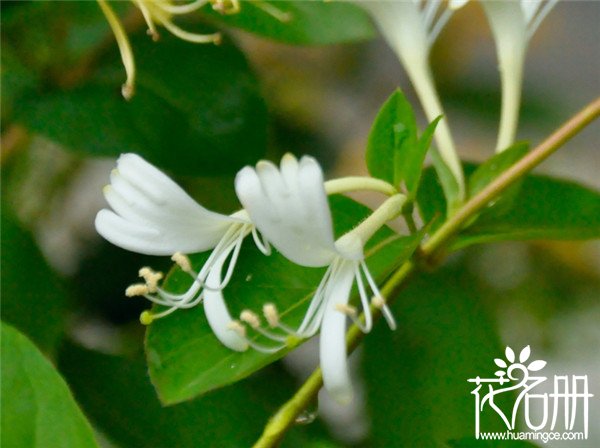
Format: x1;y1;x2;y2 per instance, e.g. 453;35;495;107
417;164;600;250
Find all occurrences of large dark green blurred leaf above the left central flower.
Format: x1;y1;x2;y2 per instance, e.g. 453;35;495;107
18;35;267;175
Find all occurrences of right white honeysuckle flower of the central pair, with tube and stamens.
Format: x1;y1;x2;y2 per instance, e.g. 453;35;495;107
231;154;405;403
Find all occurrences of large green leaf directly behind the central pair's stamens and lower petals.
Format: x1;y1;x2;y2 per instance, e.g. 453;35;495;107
146;197;419;404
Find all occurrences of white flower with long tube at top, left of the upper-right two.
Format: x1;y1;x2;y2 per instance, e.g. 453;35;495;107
354;0;465;206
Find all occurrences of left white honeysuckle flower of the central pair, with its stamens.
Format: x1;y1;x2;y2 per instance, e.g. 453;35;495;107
95;154;269;350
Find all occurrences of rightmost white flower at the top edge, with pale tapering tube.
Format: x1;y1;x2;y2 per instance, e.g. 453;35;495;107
480;0;558;151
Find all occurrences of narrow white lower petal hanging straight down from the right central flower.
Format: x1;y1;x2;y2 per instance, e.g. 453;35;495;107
320;262;354;404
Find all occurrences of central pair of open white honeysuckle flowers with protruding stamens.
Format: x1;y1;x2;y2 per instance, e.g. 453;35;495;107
96;154;406;402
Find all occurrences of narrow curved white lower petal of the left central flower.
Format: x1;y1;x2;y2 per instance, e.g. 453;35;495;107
204;248;248;352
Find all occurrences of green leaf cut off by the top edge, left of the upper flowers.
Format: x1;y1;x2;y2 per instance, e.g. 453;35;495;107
202;1;376;45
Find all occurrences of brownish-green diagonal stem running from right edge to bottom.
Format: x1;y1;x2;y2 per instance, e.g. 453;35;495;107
254;97;600;448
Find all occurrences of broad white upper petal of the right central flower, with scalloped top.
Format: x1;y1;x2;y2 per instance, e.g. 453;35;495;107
235;154;336;267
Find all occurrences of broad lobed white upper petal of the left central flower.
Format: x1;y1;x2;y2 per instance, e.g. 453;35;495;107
96;154;237;255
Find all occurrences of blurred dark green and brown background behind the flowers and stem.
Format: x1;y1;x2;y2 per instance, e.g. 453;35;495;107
1;1;600;447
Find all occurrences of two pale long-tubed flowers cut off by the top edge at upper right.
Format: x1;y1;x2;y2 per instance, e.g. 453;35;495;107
360;0;558;212
